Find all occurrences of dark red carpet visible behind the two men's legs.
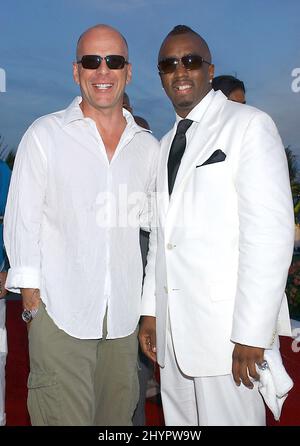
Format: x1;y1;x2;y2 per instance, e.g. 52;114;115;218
6;300;300;426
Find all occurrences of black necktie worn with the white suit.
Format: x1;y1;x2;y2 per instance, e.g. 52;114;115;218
168;119;193;195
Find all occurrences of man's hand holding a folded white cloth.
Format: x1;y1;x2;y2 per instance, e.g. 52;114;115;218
232;344;264;389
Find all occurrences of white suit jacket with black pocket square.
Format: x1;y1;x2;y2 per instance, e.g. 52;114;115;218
143;91;294;377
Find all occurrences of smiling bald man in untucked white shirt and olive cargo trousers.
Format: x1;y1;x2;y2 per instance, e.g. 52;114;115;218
5;25;158;426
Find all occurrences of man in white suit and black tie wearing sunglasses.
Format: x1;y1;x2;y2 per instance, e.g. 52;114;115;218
140;25;294;426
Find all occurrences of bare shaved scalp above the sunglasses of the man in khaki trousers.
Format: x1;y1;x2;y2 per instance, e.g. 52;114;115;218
76;24;128;60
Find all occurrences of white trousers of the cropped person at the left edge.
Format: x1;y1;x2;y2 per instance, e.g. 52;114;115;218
0;299;7;426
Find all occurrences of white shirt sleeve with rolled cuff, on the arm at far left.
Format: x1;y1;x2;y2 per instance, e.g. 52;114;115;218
4;126;47;292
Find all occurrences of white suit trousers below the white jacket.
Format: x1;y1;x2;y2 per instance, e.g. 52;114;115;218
160;324;266;426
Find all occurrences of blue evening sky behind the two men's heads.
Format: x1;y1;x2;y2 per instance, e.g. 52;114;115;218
0;0;300;161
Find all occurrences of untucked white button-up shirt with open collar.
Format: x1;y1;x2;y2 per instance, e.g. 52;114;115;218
4;97;159;339
